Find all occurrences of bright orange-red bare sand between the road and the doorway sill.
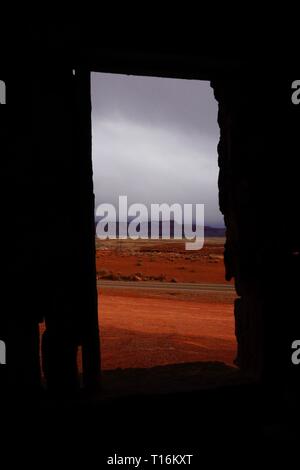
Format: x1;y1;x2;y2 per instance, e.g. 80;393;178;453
99;293;236;369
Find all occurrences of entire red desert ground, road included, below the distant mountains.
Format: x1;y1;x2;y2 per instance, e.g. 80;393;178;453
96;237;236;370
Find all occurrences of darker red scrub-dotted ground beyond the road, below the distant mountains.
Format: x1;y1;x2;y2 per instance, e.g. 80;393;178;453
96;238;231;283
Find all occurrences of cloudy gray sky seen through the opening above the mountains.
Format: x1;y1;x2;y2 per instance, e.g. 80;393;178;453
92;73;224;227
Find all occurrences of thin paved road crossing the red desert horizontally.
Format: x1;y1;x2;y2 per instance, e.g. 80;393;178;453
97;279;234;294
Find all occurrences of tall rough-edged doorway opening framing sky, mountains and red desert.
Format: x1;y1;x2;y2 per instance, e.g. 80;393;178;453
91;73;236;396
